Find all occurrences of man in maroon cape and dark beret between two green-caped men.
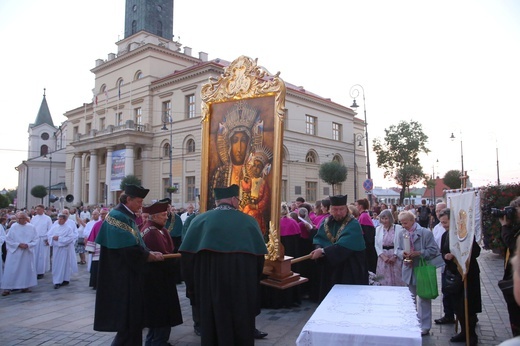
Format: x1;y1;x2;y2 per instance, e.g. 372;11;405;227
141;201;182;346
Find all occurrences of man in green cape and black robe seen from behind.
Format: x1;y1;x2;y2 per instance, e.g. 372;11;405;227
179;185;267;345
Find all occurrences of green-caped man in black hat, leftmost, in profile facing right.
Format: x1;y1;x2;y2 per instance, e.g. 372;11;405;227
94;185;164;346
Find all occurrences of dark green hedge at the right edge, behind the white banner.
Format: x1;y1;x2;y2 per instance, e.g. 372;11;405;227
480;183;520;253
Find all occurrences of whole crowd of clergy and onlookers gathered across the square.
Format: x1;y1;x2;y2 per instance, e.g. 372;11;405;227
0;192;520;345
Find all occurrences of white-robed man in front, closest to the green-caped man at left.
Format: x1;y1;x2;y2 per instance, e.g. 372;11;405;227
47;213;78;289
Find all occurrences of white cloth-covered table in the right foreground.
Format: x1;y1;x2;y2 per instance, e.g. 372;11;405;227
296;285;422;346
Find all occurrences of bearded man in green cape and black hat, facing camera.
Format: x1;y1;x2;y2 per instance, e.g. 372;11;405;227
311;195;368;301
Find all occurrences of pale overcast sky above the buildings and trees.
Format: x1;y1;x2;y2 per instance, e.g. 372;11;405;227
0;0;520;189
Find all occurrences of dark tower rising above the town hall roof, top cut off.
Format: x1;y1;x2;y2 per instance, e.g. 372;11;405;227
125;0;173;41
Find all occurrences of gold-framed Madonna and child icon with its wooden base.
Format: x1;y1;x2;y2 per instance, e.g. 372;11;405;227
200;56;308;289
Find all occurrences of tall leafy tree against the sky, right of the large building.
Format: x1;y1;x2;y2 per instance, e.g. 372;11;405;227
373;120;430;203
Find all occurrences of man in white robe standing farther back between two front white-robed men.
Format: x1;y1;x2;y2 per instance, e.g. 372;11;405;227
31;204;52;279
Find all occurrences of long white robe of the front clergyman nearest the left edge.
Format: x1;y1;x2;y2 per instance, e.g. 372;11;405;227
1;223;39;290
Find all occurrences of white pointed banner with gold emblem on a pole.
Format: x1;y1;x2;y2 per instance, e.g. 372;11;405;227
447;187;480;345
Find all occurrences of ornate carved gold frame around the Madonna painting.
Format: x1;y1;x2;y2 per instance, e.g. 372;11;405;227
200;56;286;261
